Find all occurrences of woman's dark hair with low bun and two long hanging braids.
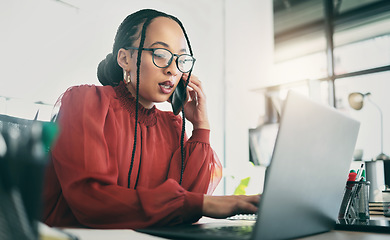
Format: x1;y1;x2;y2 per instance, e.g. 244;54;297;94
97;9;193;188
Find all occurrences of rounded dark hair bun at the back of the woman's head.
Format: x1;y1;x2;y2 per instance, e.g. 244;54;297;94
97;53;123;86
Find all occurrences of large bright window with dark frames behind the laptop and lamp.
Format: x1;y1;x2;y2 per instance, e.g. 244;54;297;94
268;0;390;160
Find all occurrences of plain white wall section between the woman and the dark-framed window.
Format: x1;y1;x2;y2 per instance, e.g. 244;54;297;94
225;0;274;194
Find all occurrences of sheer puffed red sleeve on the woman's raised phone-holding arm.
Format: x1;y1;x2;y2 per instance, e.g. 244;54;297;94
168;116;222;194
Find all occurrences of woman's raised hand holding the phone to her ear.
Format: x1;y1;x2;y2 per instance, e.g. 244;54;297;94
183;73;210;129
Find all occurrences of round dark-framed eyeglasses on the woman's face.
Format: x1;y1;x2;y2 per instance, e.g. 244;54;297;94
125;47;196;73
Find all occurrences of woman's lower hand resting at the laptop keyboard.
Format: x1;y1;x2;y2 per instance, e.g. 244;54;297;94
203;195;260;218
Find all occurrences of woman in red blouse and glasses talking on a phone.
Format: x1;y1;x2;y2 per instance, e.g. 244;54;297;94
43;9;259;229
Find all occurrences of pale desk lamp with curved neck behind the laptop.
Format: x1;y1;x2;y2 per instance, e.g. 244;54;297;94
348;92;390;160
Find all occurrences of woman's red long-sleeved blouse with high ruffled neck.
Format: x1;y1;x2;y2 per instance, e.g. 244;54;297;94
43;84;221;229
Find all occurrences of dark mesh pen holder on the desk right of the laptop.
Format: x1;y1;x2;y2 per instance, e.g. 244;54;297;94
339;181;370;220
